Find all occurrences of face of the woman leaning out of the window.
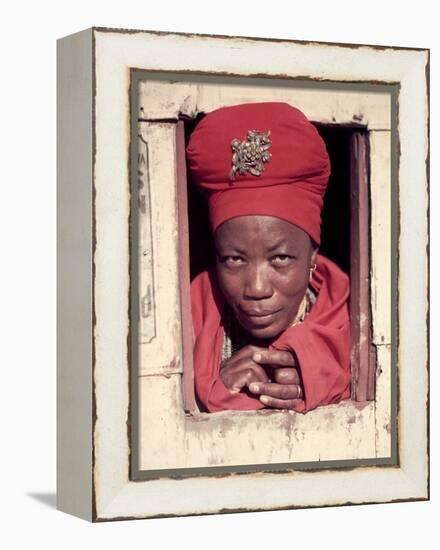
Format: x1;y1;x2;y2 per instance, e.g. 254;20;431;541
214;216;316;339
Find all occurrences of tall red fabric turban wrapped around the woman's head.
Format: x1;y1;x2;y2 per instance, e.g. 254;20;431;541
187;103;330;244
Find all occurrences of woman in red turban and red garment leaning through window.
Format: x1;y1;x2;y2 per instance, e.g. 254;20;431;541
187;103;350;412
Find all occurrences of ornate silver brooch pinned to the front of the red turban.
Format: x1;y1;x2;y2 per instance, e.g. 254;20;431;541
229;130;272;181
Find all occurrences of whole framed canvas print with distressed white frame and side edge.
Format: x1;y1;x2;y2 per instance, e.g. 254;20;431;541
57;28;429;521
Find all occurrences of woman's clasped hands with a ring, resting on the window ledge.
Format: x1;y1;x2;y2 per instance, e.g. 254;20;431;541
220;346;304;409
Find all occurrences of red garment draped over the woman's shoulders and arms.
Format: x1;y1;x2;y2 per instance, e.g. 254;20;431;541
191;255;351;412
